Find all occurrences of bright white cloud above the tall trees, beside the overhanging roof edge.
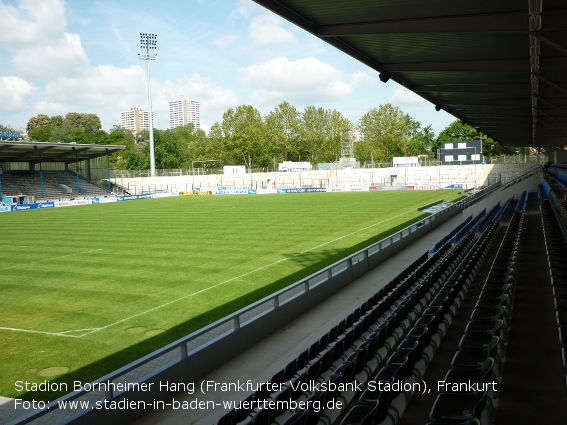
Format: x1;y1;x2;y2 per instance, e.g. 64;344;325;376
239;57;353;105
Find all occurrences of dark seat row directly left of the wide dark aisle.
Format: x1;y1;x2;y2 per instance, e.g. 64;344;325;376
429;207;524;425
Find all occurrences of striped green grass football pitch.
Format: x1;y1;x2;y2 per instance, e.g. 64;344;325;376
0;190;461;400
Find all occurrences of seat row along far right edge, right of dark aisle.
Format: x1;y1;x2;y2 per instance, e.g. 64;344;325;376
540;192;567;391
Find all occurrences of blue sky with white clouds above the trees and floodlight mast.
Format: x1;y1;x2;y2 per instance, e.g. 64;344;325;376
0;0;455;133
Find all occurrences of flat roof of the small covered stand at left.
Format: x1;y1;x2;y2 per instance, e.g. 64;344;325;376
0;140;125;163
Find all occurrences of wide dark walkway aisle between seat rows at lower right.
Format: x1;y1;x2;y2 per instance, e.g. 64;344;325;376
495;199;567;425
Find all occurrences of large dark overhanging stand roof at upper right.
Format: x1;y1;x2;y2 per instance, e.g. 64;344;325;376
254;0;567;147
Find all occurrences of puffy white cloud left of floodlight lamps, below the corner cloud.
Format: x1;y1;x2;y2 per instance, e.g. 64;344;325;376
12;33;89;79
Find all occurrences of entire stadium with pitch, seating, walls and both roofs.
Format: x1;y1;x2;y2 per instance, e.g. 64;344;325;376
0;0;567;425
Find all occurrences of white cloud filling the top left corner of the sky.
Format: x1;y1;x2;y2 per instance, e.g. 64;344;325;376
0;0;66;45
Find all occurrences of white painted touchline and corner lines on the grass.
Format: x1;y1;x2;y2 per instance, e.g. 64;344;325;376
0;208;415;338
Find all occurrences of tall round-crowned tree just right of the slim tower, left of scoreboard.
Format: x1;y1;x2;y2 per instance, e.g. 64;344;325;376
359;103;410;162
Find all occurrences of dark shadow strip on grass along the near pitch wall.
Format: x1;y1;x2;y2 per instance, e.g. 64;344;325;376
18;214;429;401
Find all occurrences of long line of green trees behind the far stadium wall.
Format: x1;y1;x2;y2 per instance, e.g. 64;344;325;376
15;102;517;170
